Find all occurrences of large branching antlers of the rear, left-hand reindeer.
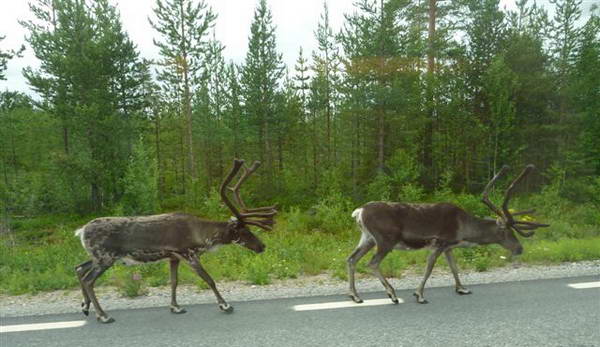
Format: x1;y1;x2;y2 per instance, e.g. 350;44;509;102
221;159;277;230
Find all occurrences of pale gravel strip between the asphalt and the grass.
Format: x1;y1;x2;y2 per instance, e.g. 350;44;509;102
0;260;600;318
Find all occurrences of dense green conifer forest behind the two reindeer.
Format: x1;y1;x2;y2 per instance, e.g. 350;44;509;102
0;0;600;292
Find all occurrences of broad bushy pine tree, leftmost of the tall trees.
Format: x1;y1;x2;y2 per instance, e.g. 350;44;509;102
22;0;148;210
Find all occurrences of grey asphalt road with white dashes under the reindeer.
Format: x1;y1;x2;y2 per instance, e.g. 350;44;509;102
0;276;600;347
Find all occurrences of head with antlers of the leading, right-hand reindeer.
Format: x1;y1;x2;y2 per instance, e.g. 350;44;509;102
481;164;550;255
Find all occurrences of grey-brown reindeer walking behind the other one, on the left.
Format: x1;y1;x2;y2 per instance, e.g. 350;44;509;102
75;159;277;323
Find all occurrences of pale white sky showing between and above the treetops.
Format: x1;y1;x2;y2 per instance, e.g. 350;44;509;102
0;0;600;94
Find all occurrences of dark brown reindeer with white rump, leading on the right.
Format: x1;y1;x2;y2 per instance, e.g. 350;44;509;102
348;165;549;304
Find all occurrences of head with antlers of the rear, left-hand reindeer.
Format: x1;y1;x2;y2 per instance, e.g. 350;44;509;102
221;159;277;253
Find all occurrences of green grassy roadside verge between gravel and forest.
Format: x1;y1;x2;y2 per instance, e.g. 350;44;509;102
0;196;600;296
